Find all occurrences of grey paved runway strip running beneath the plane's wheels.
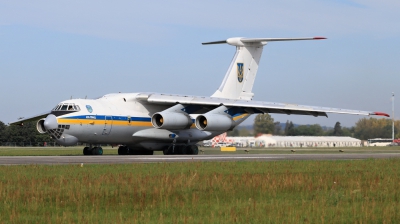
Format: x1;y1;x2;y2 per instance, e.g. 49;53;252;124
0;153;400;165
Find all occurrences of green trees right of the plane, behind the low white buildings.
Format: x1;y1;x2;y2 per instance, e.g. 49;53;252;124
228;114;400;140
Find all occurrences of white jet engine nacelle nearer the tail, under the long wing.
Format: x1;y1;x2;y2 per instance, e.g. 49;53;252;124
196;113;234;131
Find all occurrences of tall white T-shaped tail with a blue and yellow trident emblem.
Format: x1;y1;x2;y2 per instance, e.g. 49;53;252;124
203;37;326;100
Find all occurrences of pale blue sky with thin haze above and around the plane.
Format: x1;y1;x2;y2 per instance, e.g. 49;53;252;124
0;0;400;127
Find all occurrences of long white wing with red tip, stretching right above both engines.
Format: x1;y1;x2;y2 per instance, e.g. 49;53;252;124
137;93;389;117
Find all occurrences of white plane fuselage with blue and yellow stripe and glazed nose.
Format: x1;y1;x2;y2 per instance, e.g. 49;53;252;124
48;93;248;150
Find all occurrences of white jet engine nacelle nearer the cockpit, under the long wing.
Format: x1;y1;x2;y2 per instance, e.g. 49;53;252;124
151;111;193;130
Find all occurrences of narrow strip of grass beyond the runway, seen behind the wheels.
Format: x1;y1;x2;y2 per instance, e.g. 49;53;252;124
0;146;400;156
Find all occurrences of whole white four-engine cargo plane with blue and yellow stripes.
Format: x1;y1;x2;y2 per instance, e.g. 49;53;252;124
10;37;389;155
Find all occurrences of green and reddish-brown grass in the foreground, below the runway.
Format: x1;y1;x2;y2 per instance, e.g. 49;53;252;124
0;159;400;223
